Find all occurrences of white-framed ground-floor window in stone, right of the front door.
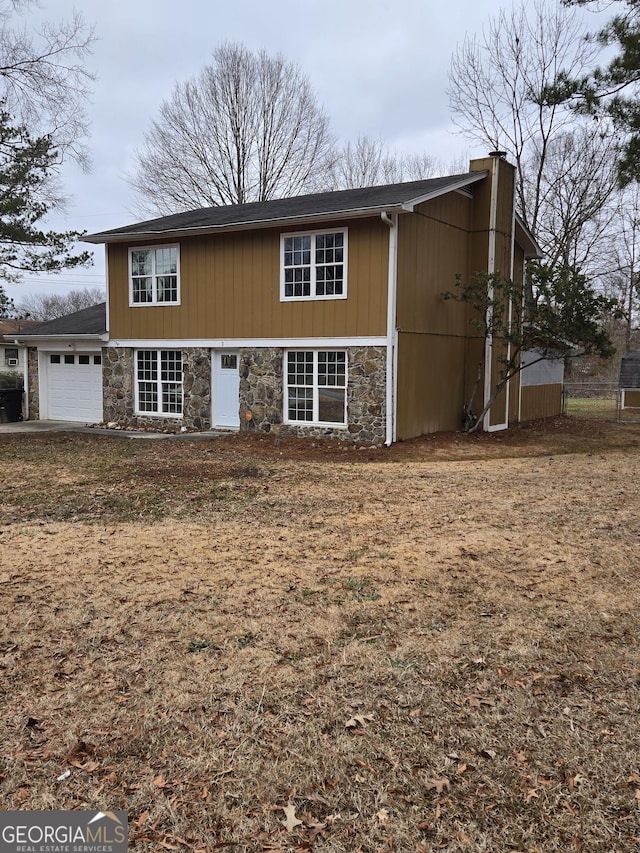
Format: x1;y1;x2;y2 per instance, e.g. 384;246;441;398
284;350;347;426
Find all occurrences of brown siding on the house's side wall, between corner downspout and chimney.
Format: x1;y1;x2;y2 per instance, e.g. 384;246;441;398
396;193;472;439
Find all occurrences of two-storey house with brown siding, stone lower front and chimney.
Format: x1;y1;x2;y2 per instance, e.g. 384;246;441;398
17;154;561;444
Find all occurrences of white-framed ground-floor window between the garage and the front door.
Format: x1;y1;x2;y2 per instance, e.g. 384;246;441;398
135;349;182;417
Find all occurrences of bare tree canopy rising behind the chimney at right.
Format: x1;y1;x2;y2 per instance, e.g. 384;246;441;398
449;0;619;266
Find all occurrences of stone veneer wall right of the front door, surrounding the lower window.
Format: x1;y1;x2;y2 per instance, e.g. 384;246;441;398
240;347;386;444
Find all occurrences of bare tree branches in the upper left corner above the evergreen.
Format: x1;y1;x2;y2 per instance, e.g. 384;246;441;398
0;0;94;166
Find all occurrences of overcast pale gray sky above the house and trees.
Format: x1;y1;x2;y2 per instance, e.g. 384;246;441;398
7;0;536;299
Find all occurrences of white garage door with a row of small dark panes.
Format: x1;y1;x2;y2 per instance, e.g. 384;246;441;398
46;352;102;423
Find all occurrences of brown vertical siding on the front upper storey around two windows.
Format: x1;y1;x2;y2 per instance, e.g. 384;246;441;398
108;219;389;340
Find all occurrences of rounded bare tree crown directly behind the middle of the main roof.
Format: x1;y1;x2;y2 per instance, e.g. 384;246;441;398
128;44;333;214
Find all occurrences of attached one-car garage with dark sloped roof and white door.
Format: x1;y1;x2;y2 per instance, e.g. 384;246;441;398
14;302;107;423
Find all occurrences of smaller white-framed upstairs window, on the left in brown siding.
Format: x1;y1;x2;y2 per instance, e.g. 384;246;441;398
129;246;180;306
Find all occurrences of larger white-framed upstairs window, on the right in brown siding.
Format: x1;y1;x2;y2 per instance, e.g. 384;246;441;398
280;228;347;302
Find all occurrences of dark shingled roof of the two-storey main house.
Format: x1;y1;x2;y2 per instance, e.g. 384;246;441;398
85;172;487;243
